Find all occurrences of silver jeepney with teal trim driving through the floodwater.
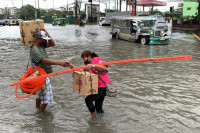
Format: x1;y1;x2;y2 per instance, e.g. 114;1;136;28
110;15;171;45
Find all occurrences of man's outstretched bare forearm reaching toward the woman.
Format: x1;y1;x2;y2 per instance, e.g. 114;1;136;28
40;58;73;68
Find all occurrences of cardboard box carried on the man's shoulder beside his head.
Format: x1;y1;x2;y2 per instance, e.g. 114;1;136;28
19;19;44;46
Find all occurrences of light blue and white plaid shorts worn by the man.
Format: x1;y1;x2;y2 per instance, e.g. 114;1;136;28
36;77;53;104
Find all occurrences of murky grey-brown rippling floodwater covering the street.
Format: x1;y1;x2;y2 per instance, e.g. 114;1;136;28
0;24;200;133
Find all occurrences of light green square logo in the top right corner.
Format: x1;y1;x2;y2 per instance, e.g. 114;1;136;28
183;0;199;17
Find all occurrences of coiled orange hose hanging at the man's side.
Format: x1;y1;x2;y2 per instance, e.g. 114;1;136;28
15;66;46;99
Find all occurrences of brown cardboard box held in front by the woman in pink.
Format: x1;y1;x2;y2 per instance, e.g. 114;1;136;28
73;71;98;96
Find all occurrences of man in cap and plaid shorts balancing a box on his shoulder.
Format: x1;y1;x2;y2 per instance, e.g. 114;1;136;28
30;29;73;112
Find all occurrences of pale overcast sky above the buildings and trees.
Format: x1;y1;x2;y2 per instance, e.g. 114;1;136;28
0;0;183;12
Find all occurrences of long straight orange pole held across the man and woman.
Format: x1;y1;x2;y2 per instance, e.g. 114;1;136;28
10;55;191;99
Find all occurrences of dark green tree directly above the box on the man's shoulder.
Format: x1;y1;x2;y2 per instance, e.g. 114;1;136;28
18;5;35;20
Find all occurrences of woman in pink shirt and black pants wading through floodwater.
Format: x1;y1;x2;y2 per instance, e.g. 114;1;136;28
81;50;111;116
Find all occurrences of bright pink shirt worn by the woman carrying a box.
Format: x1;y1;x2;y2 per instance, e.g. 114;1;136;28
89;57;111;88
